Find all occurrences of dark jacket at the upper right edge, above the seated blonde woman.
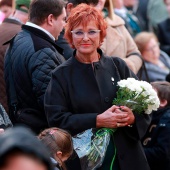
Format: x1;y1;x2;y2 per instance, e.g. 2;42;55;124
158;18;170;56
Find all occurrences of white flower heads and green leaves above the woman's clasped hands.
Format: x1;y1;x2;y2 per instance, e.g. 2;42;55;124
113;78;160;114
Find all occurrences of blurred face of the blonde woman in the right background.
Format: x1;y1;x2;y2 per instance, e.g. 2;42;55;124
142;38;160;63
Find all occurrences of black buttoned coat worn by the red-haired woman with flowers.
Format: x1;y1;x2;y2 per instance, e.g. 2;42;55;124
45;51;150;170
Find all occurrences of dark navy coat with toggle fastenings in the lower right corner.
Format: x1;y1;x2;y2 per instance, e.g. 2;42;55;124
143;107;170;170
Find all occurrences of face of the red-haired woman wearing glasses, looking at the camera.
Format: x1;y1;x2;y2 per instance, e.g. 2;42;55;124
72;21;100;55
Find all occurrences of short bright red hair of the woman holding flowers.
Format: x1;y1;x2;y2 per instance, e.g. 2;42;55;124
64;3;107;47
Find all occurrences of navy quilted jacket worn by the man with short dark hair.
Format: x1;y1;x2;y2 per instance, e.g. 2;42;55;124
5;25;65;133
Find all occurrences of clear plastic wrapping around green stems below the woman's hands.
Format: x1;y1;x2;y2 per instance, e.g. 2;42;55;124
72;128;116;170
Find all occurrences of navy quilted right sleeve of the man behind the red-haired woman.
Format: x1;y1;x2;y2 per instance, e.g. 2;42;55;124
28;48;64;109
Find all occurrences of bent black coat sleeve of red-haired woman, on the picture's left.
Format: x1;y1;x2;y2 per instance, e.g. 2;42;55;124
44;70;99;135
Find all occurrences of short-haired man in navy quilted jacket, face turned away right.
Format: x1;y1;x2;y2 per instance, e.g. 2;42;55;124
4;0;66;133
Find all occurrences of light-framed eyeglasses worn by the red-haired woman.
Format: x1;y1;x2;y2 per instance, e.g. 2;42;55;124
71;30;101;38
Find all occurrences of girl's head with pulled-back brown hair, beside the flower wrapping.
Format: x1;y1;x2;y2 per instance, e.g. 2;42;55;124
38;127;73;164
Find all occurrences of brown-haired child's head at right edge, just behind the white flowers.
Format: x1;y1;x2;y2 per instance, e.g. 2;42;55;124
151;81;170;107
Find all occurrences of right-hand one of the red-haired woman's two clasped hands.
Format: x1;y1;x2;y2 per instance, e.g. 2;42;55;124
115;106;135;127
